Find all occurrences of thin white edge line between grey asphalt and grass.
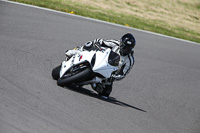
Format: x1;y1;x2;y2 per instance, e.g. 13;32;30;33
0;0;200;46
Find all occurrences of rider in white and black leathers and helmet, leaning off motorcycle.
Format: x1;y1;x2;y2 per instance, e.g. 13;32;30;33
66;33;136;96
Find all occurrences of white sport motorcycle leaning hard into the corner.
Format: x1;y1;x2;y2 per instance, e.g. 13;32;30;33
52;45;120;96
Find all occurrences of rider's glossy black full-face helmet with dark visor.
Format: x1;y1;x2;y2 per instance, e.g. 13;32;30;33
119;33;135;56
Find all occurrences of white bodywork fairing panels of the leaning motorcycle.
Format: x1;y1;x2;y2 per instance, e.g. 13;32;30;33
60;48;118;83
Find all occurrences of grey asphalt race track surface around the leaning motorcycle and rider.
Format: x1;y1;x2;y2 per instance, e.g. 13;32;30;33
0;1;200;133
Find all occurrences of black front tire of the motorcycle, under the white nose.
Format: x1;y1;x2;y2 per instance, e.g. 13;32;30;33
57;68;91;87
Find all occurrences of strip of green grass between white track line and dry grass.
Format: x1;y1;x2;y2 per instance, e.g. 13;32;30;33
12;0;200;43
